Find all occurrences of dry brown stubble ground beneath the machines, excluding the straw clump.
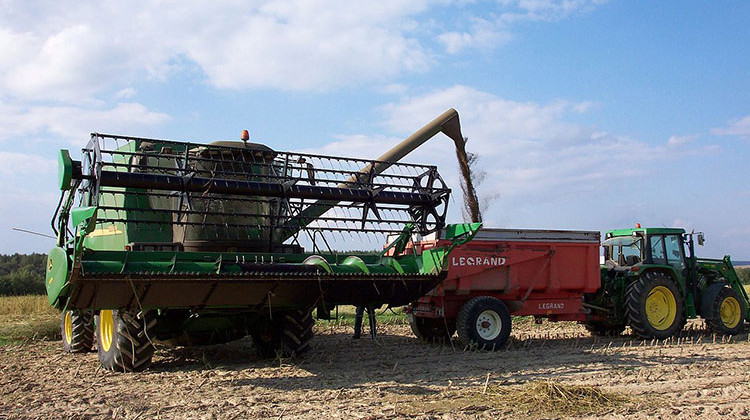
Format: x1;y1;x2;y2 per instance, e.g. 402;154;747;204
0;321;750;419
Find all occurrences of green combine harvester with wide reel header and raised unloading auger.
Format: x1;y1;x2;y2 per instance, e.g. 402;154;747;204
46;109;479;371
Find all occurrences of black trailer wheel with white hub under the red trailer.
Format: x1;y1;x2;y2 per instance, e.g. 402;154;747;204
456;296;511;350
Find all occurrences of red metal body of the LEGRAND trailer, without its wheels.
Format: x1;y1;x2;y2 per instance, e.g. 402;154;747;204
408;229;601;321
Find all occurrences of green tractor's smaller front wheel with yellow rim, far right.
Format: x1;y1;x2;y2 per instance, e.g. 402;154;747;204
701;283;745;335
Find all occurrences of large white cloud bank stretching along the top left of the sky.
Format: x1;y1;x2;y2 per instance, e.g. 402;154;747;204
0;0;612;98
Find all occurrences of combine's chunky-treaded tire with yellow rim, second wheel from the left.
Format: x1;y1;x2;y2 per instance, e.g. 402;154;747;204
96;310;156;372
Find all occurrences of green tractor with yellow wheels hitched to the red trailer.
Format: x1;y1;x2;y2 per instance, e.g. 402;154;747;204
584;225;750;340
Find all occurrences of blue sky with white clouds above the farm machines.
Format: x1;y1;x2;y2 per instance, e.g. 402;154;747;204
0;0;750;260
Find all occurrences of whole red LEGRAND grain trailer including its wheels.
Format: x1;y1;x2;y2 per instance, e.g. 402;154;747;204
407;229;601;349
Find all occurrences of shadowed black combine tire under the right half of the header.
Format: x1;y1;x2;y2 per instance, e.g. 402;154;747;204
251;309;315;358
